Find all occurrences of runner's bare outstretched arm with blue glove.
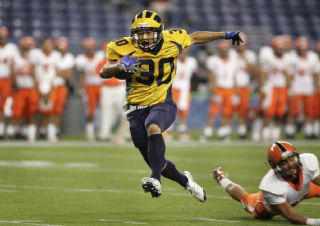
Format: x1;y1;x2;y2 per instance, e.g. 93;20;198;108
190;31;243;45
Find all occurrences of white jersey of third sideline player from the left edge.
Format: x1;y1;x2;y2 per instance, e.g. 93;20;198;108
30;49;61;94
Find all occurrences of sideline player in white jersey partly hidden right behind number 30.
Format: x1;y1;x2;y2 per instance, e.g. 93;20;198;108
172;48;198;141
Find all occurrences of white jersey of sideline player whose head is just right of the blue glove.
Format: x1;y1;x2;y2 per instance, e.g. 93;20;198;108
233;49;257;87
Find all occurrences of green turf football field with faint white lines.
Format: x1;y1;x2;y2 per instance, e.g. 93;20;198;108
0;141;320;226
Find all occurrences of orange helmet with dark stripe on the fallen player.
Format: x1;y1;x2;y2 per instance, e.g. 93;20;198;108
268;141;301;179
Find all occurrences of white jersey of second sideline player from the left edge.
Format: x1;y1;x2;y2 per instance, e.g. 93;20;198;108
14;54;35;89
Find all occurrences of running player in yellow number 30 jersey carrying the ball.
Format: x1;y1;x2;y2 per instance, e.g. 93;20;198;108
100;10;242;202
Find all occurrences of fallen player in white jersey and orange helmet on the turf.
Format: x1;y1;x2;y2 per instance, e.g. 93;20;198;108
213;141;320;225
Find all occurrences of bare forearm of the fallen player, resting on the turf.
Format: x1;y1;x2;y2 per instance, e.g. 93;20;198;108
273;202;320;226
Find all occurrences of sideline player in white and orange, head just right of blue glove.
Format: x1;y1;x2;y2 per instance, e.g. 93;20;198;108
233;34;257;138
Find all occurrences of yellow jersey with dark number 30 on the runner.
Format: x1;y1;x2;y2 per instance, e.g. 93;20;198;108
107;29;191;106
